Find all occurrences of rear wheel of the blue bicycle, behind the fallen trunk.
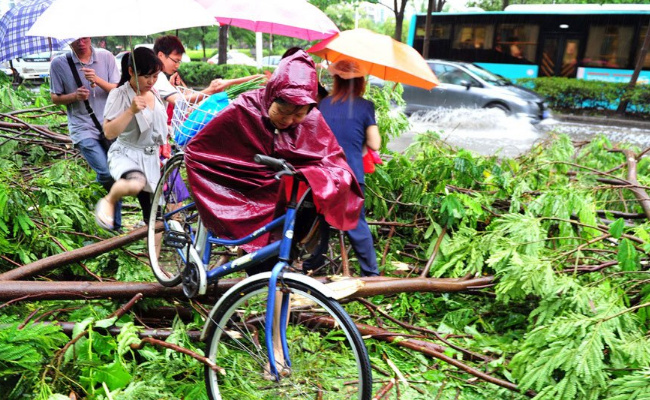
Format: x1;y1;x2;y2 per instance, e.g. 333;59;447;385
147;153;203;286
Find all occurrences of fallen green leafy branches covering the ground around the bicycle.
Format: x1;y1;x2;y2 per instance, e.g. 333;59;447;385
0;76;650;400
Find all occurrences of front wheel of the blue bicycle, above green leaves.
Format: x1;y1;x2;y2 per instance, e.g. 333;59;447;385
205;274;372;400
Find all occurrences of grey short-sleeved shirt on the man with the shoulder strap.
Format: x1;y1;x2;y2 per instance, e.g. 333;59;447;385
50;48;120;143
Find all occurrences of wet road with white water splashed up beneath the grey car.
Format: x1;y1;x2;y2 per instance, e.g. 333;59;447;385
388;109;650;157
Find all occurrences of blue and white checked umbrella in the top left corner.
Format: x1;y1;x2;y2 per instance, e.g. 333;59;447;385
0;0;75;62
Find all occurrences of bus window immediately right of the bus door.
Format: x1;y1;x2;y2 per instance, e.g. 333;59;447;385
583;25;634;68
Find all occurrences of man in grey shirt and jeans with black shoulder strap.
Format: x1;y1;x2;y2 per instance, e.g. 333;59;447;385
50;37;122;231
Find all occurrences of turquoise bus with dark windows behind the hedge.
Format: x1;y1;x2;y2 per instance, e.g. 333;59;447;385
408;4;650;83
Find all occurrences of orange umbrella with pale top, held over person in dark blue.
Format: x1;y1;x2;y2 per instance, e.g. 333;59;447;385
307;28;438;90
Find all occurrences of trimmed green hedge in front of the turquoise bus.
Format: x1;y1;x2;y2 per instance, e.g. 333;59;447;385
517;78;650;115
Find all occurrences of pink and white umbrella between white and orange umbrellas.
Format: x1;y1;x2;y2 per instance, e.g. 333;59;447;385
197;0;339;40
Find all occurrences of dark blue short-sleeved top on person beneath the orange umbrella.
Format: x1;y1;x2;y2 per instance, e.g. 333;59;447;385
318;97;377;184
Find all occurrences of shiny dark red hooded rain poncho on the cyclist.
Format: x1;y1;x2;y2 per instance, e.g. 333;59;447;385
185;51;363;251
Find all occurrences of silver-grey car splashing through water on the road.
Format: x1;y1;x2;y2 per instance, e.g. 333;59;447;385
371;60;550;123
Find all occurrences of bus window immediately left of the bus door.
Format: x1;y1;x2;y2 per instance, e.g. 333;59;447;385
494;24;539;62
